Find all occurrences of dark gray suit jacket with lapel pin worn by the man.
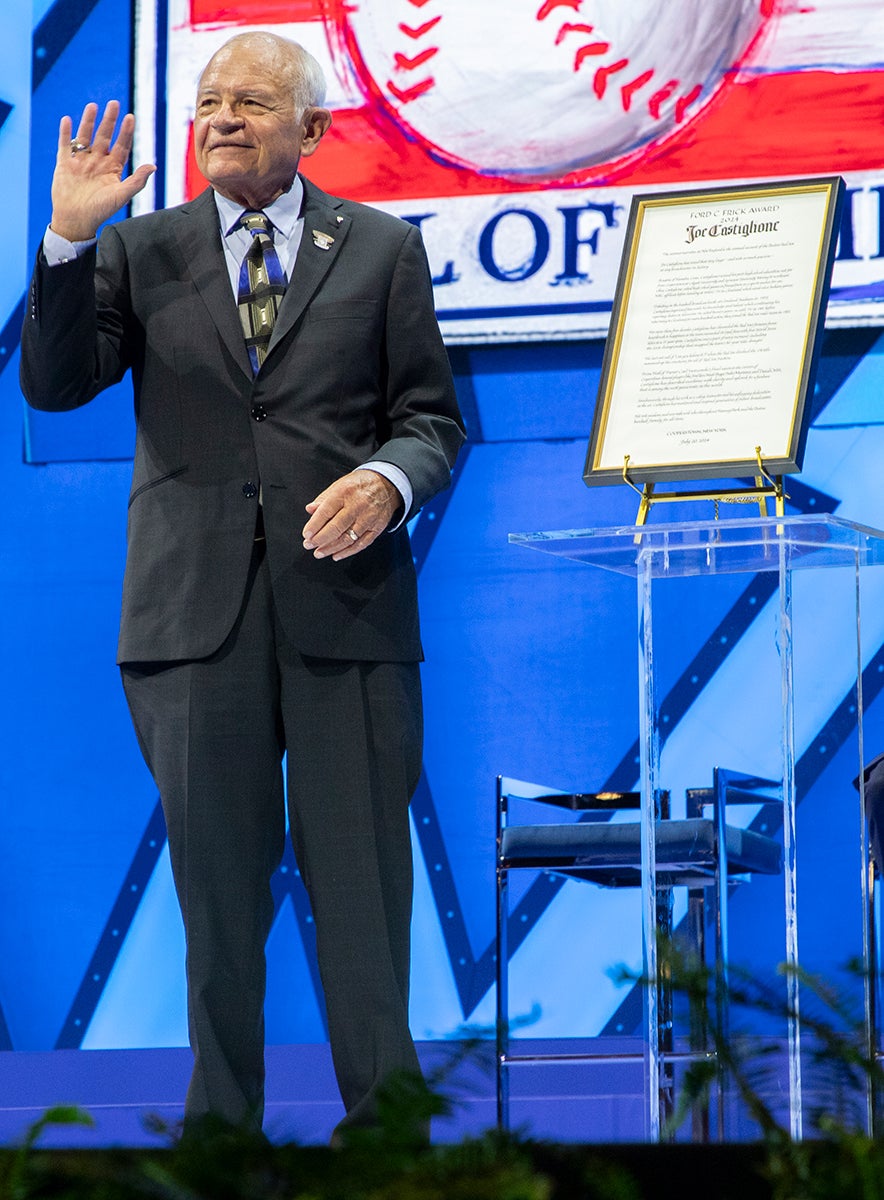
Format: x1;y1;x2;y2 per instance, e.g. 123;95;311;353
22;180;463;662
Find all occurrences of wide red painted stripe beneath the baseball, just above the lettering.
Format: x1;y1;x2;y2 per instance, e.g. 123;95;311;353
187;71;884;202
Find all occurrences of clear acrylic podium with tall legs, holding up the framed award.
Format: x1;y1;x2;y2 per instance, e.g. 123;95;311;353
510;515;884;1140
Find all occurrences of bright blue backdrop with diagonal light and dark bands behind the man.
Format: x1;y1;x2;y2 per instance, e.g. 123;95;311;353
0;0;884;1070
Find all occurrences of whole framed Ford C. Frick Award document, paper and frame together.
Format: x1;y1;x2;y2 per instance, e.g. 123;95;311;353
583;176;843;486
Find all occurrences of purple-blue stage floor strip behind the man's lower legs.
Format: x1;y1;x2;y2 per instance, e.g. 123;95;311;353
0;1038;814;1148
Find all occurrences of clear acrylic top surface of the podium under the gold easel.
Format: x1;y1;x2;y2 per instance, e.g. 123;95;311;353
509;514;884;578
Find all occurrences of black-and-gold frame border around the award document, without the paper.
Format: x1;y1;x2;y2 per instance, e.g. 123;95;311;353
583;175;844;499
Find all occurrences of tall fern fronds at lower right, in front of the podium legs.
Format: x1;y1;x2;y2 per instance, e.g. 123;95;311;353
615;938;884;1200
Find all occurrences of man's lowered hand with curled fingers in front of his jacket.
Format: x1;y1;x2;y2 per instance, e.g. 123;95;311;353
302;469;402;563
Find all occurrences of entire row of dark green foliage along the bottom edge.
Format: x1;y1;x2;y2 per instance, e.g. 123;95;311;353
8;943;884;1200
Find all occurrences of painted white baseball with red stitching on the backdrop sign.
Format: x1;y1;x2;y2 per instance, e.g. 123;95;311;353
329;0;771;179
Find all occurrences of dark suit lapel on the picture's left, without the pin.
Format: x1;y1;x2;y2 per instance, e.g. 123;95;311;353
175;188;252;379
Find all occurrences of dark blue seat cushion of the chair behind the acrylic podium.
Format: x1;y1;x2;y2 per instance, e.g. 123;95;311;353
500;817;782;887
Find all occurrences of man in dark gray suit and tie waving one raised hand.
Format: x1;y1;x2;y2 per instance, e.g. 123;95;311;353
22;34;463;1124
